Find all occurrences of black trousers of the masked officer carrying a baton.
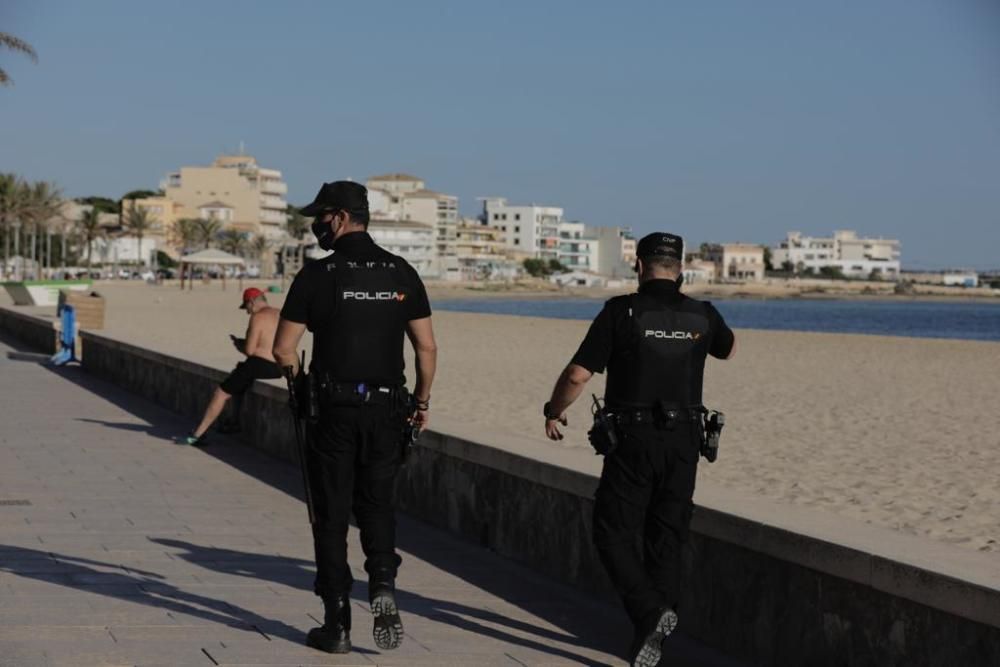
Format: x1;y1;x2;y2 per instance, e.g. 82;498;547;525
307;403;405;598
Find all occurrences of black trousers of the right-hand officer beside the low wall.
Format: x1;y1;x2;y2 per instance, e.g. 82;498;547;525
594;421;700;626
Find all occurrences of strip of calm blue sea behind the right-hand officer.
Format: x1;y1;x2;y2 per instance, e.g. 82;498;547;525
434;299;1000;341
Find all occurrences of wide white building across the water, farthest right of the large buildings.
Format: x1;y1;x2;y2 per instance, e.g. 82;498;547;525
771;230;900;278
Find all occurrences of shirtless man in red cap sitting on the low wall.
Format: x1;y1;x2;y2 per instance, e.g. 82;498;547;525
179;287;281;445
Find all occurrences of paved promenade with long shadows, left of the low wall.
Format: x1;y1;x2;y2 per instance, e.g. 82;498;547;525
0;340;734;667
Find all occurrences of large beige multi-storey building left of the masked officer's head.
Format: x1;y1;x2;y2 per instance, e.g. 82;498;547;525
161;155;288;239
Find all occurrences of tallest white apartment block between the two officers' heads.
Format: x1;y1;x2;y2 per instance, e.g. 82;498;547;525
482;197;563;260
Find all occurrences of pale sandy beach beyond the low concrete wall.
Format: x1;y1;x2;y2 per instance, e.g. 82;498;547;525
3;282;1000;552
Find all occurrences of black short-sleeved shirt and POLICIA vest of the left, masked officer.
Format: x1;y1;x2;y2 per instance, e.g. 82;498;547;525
281;232;431;384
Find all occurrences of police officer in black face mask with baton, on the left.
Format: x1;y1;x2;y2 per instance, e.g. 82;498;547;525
274;181;437;653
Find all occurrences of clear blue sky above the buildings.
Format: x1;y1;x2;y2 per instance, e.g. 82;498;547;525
0;0;1000;268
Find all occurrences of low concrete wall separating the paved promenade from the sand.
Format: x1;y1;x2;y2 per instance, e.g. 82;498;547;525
0;318;1000;665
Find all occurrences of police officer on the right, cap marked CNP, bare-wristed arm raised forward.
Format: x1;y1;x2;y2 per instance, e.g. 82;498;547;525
544;233;735;667
